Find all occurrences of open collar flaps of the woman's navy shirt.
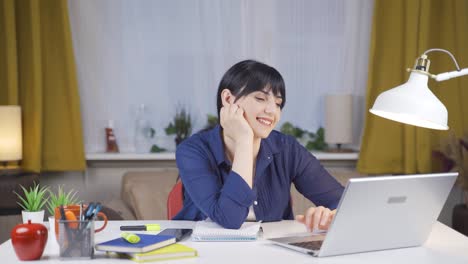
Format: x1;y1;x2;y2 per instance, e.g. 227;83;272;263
208;124;280;165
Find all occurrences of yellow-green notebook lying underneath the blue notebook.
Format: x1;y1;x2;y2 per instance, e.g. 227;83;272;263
126;243;198;262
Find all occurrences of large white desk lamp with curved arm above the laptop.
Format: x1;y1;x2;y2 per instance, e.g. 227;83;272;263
369;49;468;130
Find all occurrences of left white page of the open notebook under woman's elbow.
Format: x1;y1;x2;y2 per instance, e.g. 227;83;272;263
192;220;261;241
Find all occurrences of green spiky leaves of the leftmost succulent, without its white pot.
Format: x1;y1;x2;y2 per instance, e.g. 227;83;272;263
13;183;49;212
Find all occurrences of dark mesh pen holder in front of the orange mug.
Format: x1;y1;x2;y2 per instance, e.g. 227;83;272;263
58;220;94;259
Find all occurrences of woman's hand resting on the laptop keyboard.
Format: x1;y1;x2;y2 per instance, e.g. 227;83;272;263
296;206;336;232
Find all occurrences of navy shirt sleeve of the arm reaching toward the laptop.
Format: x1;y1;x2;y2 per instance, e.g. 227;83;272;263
291;139;344;210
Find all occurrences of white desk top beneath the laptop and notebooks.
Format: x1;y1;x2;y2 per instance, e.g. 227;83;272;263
0;221;468;264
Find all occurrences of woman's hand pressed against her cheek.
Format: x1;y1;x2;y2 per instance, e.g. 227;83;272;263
220;104;253;144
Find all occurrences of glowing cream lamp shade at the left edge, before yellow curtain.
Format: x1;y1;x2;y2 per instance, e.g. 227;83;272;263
0;106;23;161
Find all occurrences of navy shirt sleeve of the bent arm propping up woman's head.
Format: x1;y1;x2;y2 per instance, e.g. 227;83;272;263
176;142;255;229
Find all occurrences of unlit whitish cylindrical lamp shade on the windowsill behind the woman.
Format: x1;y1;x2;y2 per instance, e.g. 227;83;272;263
325;94;353;144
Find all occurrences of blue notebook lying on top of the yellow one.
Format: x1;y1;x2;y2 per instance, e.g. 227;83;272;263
95;234;176;253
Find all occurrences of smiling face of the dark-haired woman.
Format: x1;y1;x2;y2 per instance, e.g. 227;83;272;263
235;88;283;138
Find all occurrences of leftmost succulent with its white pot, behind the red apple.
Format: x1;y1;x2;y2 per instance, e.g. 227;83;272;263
14;183;48;223
